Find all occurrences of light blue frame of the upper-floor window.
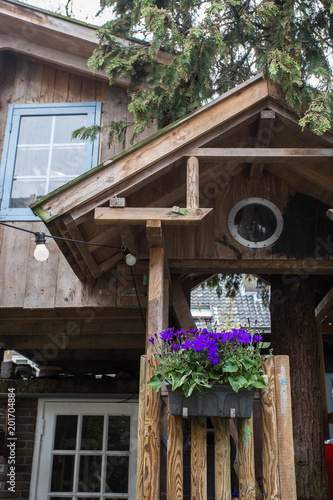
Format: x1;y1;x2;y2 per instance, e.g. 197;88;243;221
0;102;102;221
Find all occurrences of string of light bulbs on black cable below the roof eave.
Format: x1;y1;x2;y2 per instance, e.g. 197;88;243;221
0;222;136;266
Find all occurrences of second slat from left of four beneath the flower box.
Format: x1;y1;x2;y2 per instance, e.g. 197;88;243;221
191;417;207;500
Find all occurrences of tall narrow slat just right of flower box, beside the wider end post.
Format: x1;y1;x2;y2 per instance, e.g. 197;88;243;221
260;357;278;500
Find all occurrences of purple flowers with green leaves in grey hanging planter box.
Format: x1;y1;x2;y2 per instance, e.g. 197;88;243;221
148;324;270;412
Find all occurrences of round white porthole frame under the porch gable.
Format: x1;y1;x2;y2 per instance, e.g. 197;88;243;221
228;198;283;248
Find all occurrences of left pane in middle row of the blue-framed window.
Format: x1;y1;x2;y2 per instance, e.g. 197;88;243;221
14;147;49;177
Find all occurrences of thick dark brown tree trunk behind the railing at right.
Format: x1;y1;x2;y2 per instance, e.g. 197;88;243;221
271;275;329;500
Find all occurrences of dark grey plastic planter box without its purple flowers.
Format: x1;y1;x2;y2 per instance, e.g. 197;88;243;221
166;384;255;418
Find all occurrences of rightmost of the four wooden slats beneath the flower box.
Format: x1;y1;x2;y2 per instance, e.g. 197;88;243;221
238;413;256;500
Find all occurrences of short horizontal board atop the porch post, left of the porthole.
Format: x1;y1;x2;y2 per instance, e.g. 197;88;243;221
94;207;213;226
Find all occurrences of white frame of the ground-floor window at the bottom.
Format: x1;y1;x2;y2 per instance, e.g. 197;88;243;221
29;398;138;500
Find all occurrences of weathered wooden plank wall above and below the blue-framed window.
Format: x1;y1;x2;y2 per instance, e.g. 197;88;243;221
0;52;152;308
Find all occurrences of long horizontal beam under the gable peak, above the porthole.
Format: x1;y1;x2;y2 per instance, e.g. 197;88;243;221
186;148;333;163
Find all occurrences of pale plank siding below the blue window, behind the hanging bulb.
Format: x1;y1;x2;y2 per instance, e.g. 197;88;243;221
0;222;116;309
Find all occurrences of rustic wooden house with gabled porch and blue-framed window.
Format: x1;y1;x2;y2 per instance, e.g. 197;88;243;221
0;4;333;492
